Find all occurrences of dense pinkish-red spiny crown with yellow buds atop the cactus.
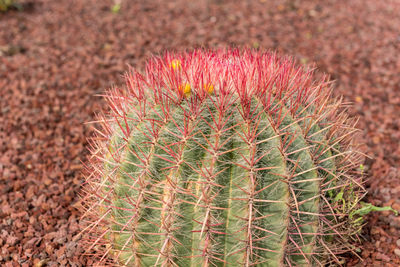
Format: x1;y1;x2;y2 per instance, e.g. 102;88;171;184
121;50;322;103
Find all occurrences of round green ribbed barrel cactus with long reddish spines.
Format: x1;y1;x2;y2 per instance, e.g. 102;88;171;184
83;50;364;267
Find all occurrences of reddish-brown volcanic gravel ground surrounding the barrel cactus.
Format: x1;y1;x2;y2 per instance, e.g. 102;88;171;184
0;0;400;266
